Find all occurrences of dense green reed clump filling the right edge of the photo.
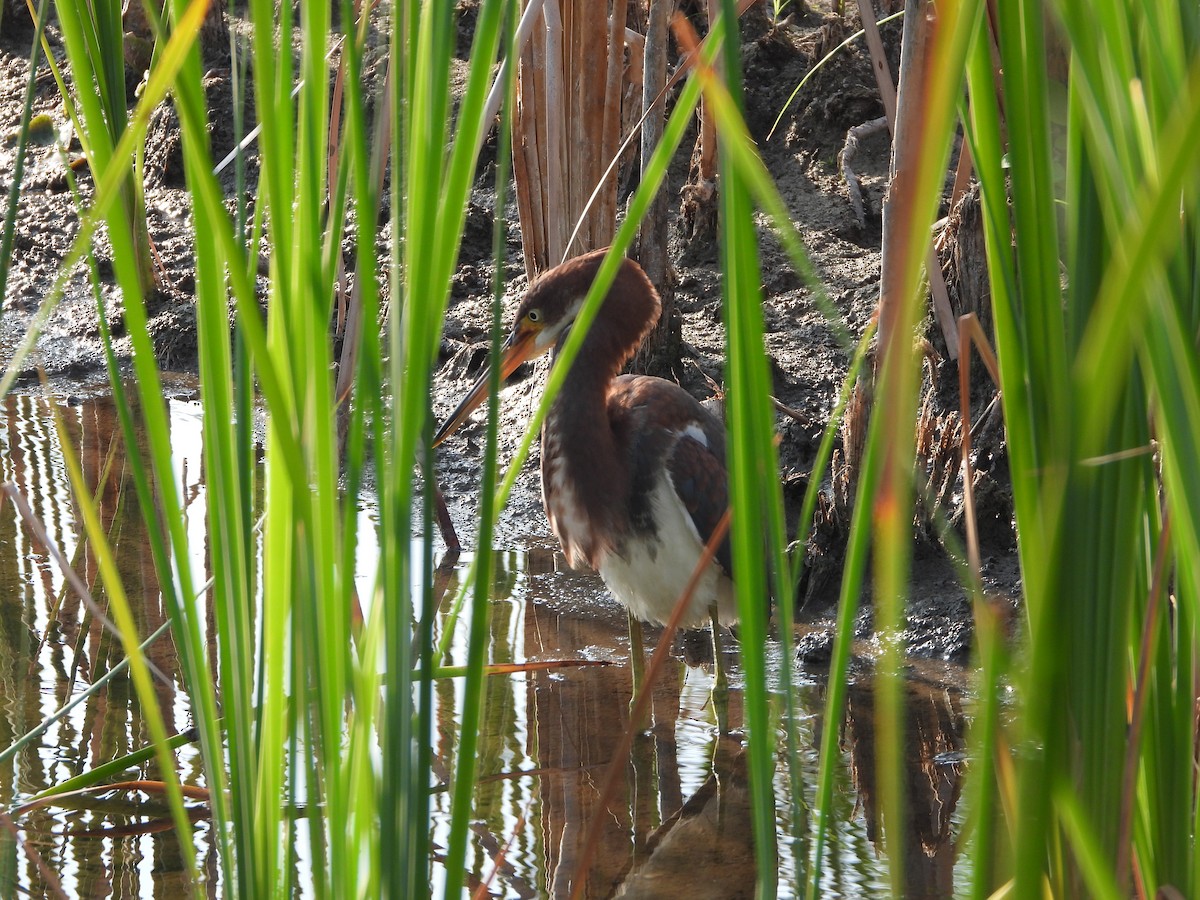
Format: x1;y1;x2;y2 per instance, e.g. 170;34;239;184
967;1;1200;896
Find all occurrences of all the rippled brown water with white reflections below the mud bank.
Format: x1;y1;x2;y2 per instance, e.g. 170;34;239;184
0;395;965;900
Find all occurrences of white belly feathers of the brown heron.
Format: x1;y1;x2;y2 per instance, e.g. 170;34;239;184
600;478;738;628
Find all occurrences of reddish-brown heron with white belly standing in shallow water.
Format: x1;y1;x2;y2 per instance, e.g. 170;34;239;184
433;250;737;710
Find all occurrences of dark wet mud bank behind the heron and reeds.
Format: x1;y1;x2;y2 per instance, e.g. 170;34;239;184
0;4;1019;661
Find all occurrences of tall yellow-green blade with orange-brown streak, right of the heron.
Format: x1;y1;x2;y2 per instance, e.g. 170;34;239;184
809;4;980;896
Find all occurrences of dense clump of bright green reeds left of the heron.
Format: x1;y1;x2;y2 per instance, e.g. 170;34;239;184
10;1;511;896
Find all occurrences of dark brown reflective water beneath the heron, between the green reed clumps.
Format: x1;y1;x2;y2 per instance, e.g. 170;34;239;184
436;551;966;900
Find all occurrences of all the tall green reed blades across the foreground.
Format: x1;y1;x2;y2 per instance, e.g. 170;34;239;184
7;0;1200;898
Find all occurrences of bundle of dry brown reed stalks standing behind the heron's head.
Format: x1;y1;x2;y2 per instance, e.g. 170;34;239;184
512;0;755;371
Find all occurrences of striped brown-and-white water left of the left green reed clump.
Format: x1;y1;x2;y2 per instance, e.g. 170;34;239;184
0;386;215;898
